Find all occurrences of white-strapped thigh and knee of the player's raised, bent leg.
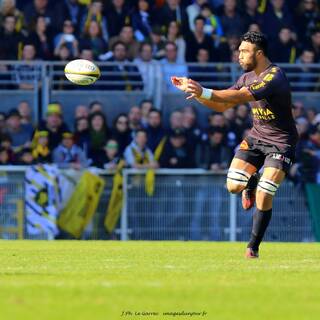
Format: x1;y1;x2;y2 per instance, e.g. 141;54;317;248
227;158;257;193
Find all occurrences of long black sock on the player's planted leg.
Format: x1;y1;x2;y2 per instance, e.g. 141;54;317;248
248;209;272;250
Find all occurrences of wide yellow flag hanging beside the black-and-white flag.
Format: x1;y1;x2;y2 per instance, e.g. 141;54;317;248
58;171;105;238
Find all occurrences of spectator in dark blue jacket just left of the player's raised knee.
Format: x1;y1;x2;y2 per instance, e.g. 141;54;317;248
201;127;232;172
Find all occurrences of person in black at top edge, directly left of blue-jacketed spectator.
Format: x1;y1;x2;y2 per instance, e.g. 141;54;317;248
106;0;131;38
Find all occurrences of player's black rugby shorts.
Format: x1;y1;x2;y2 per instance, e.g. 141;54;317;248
234;137;295;173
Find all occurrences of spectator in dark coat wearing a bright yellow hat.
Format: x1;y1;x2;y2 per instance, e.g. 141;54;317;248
37;103;69;151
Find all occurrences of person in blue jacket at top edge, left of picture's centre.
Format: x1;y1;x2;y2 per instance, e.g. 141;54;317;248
132;0;152;42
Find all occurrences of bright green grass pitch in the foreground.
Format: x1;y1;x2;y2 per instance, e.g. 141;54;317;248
0;241;320;320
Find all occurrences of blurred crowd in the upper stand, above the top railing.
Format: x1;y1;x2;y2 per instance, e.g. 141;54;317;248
0;0;320;63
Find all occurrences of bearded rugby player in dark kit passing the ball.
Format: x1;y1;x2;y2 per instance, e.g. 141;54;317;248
172;32;298;258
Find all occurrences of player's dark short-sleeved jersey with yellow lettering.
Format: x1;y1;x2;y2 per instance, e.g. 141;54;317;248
232;64;298;146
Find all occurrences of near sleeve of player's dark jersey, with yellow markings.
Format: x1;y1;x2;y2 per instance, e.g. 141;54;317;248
247;69;284;101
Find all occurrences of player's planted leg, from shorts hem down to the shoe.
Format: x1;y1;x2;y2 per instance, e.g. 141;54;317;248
246;167;285;258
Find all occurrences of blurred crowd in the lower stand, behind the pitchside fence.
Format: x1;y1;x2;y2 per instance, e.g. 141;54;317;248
0;100;320;183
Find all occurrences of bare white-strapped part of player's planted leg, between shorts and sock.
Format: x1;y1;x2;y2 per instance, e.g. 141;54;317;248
256;167;286;211
